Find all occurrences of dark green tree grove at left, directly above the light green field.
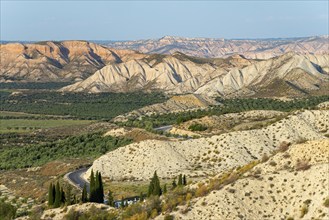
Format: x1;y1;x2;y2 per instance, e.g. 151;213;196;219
0;91;167;120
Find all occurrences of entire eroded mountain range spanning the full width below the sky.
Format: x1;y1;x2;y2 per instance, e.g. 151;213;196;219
0;36;329;96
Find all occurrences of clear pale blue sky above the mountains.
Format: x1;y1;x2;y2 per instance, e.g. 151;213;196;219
0;0;329;41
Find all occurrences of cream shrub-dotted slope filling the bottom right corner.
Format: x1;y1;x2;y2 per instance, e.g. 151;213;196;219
170;139;329;219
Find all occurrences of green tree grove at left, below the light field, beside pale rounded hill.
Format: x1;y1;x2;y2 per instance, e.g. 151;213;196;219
0;133;131;170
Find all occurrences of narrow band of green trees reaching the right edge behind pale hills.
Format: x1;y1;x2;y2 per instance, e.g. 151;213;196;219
118;96;329;129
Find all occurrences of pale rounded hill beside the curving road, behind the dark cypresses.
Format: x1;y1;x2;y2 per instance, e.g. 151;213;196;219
86;110;329;180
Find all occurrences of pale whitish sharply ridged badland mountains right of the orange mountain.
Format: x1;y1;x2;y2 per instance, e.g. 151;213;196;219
62;52;329;96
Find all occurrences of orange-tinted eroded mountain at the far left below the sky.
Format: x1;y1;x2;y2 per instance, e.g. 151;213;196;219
0;41;143;82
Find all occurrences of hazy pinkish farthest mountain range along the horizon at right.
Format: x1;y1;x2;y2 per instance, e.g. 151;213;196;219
100;35;329;59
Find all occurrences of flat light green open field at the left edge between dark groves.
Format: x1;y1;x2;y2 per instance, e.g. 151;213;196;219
0;119;92;133
